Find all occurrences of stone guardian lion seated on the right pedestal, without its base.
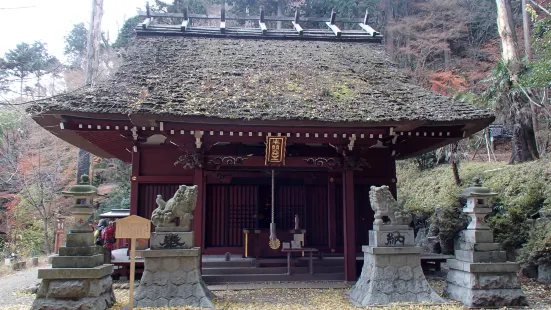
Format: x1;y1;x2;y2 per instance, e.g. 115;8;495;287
369;185;411;225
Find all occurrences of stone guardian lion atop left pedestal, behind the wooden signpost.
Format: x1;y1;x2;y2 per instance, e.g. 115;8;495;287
151;185;197;231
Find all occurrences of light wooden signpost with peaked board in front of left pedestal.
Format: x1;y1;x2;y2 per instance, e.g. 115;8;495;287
115;215;151;309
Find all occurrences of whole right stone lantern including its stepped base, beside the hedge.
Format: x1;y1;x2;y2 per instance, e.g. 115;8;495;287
444;178;527;308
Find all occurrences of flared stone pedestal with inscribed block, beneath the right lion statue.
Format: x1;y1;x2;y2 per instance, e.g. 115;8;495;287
350;225;443;307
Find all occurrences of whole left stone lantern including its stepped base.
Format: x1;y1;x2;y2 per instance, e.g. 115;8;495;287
31;175;115;310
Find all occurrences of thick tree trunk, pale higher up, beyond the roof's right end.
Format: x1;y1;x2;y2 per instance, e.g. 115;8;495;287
496;0;539;163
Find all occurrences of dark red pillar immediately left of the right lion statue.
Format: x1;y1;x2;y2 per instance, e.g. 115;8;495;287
343;169;356;281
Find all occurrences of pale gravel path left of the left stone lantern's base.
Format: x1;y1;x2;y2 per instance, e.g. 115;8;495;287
0;267;39;309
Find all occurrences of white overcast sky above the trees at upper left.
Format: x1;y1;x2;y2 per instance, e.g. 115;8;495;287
0;0;146;61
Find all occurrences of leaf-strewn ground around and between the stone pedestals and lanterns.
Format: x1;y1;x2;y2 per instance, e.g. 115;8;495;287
0;268;551;310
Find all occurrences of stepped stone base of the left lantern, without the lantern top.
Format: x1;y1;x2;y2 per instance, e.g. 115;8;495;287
31;232;115;310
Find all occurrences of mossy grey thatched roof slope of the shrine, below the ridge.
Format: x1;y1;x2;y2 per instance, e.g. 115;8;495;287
35;37;492;123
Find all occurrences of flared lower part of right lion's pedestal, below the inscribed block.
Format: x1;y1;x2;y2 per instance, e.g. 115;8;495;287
349;246;443;307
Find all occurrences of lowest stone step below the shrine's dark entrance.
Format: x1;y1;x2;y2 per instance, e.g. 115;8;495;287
203;269;344;284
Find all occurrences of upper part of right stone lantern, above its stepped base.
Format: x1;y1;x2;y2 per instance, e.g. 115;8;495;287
459;177;497;230
